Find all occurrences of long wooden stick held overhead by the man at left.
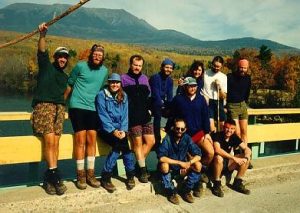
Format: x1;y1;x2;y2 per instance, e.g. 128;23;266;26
0;0;90;49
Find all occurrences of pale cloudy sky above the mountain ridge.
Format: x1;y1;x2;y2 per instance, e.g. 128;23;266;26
0;0;300;49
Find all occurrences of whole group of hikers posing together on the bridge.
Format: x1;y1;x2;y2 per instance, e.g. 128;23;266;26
32;23;251;204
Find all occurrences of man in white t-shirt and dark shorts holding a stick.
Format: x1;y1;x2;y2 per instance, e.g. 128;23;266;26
202;56;227;131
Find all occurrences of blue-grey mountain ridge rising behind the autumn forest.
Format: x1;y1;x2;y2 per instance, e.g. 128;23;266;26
0;3;300;54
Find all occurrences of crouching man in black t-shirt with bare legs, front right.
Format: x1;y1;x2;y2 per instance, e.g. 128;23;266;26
212;120;251;197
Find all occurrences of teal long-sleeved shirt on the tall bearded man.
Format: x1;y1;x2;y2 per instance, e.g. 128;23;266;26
68;61;108;111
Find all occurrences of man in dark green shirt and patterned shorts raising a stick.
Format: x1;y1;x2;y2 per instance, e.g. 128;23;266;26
31;23;69;195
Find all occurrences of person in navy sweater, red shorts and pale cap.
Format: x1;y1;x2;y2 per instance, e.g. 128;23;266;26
166;77;214;197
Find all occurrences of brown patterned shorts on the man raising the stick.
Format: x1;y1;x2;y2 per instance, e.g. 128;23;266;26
31;103;65;136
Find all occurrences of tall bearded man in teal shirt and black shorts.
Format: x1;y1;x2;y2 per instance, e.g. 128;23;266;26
65;44;108;190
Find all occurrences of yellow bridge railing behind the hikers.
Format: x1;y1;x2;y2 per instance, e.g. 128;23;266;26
0;108;300;165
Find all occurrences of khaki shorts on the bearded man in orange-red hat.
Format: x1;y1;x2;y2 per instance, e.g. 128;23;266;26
227;101;248;120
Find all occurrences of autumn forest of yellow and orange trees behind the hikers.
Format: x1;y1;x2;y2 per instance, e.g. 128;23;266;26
0;31;300;108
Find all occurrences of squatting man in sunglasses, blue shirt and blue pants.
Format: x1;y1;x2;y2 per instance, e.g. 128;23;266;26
157;119;201;205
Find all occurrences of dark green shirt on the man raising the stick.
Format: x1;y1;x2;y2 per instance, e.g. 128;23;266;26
32;51;68;107
